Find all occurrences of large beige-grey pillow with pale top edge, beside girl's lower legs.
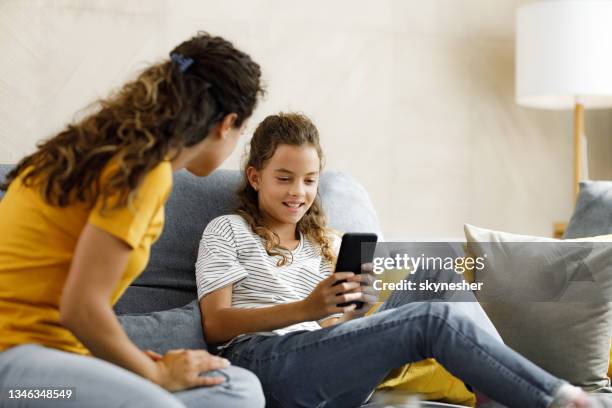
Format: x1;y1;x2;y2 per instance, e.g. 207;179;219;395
465;225;612;391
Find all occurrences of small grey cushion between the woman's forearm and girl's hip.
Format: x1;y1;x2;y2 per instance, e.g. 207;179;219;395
119;300;207;354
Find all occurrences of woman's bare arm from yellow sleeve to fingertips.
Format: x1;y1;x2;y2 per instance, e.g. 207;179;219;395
60;224;228;391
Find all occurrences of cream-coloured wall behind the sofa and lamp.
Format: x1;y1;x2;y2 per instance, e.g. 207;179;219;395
0;0;612;238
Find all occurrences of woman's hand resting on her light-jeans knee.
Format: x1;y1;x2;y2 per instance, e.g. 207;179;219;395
152;349;230;391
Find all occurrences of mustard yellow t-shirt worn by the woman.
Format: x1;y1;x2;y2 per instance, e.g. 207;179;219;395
0;161;172;354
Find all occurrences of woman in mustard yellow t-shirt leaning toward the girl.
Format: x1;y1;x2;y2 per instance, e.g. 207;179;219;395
0;33;264;408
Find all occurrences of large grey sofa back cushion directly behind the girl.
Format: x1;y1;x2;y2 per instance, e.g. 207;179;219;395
115;170;380;314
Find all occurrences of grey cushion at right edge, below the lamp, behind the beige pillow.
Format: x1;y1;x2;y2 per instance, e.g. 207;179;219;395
563;181;612;238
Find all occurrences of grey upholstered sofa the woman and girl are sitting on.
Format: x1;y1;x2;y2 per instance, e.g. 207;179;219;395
0;165;612;407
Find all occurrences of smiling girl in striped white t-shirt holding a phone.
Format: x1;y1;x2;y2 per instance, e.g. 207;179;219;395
196;114;608;408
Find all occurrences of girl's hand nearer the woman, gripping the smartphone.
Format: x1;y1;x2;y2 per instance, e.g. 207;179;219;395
301;272;363;320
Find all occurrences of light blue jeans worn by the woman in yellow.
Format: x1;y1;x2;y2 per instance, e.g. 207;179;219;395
0;344;264;408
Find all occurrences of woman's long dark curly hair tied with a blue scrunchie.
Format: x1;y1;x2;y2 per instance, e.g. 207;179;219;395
0;32;263;209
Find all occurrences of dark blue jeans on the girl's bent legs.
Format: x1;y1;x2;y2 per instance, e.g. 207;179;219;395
222;292;564;408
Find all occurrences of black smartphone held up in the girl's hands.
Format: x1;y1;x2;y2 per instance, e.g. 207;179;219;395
334;232;378;309
